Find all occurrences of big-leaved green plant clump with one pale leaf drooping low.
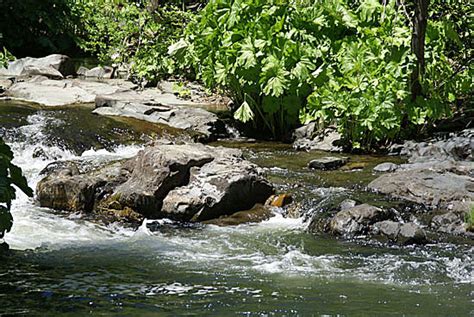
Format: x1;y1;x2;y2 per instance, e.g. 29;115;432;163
177;0;322;136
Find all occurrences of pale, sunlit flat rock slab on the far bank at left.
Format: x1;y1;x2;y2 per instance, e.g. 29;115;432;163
6;76;136;107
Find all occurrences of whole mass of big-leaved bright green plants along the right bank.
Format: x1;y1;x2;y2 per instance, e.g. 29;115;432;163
179;0;472;149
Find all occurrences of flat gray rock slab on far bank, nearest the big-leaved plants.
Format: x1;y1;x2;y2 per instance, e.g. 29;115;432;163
94;89;227;141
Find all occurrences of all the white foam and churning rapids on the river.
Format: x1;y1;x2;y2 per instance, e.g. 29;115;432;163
2;115;474;288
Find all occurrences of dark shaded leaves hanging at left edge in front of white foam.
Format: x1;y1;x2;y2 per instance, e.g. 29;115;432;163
0;139;33;238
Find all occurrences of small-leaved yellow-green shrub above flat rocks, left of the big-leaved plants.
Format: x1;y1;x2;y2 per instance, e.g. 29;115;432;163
75;0;191;81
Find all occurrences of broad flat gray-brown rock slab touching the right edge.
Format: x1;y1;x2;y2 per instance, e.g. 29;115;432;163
368;170;474;211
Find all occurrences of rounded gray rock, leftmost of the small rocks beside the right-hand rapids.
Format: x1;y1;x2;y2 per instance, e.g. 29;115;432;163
329;204;389;235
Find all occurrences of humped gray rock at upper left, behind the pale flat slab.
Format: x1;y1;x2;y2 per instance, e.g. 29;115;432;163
0;54;74;77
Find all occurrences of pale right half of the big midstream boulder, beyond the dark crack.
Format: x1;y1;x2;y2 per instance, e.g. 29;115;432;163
162;148;273;221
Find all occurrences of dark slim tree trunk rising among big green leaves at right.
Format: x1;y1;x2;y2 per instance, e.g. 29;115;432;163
411;0;430;100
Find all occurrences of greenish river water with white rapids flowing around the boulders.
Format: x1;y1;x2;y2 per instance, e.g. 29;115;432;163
0;102;474;316
